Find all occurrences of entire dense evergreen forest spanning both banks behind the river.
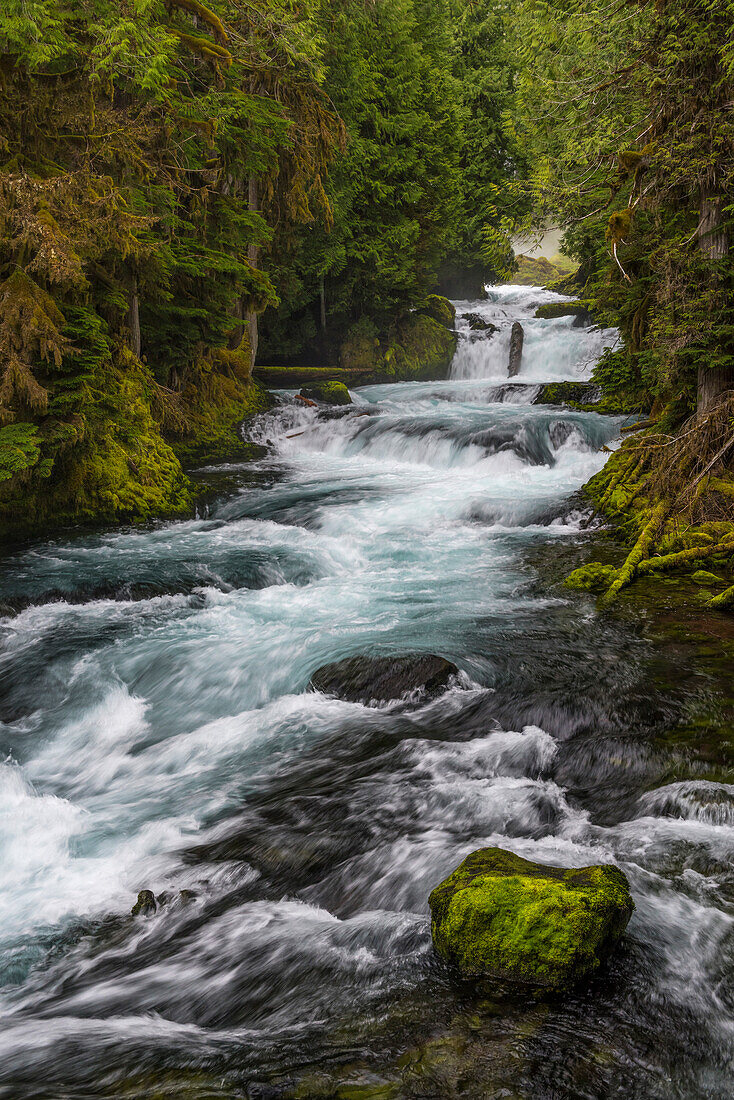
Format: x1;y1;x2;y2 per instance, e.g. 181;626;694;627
0;0;734;534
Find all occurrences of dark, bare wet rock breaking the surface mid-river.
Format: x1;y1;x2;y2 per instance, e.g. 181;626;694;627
311;653;459;705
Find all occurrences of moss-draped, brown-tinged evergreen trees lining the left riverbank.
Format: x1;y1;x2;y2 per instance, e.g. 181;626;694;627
0;0;340;526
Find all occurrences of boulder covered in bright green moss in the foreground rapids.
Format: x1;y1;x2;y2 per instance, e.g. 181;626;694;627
429;848;635;991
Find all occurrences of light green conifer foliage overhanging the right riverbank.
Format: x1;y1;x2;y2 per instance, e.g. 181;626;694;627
516;0;734;422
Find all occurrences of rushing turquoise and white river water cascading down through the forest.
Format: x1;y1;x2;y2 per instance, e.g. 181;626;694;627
0;287;734;1100
